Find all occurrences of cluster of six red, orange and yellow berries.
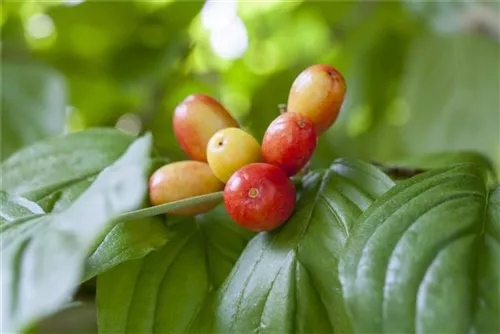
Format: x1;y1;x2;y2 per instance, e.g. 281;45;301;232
149;65;346;231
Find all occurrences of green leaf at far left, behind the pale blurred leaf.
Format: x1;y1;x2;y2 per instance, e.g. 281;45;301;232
0;129;134;211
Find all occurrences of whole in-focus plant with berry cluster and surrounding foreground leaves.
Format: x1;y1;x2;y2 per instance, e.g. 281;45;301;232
0;65;500;334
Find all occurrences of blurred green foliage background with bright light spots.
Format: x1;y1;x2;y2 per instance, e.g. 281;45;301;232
0;0;500;333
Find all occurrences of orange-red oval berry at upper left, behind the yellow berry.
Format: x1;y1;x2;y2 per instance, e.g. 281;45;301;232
173;94;238;161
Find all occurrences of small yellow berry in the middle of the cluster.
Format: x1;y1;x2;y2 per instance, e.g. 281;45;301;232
207;128;262;183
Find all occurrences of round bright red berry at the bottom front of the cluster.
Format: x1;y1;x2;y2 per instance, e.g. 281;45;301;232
224;163;295;231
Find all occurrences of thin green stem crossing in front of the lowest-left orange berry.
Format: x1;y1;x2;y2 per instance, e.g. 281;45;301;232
116;191;224;221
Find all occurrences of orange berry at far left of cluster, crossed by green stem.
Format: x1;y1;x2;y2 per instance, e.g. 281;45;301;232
149;161;224;216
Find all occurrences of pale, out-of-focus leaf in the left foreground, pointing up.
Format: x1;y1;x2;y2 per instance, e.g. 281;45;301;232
1;135;151;332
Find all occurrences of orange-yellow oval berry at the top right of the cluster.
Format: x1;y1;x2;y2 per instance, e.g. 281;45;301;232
287;65;346;136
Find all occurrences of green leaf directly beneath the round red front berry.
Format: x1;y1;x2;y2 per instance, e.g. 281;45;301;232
208;159;393;333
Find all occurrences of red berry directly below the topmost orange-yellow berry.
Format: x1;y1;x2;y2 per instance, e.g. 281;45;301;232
262;112;317;176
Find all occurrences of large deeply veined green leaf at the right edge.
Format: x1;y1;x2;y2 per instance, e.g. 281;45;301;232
340;164;500;334
